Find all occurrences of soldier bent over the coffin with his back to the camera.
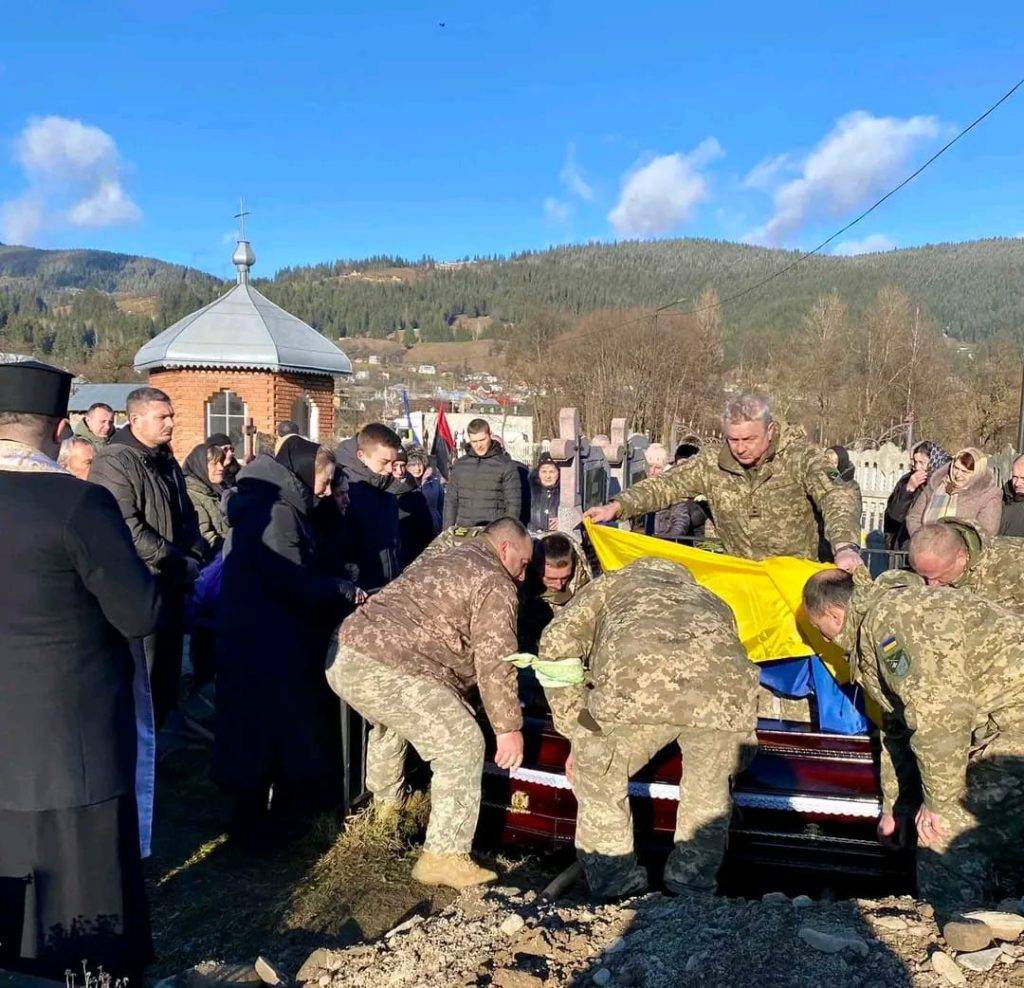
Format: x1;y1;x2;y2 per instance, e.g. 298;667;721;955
540;558;758;898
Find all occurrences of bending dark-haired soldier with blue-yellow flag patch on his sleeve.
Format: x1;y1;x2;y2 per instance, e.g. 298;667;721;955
804;570;1024;937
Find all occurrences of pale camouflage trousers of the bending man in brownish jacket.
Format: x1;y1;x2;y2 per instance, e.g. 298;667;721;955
327;646;483;854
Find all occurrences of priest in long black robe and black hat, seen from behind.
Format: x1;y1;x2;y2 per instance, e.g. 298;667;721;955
0;360;160;985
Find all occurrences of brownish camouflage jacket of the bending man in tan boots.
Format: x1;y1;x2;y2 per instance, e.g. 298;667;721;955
338;539;522;734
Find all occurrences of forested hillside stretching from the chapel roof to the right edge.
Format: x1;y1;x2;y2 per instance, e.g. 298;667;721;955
259;239;1024;341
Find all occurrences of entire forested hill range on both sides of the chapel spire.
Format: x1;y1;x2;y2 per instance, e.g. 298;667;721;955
0;240;1024;380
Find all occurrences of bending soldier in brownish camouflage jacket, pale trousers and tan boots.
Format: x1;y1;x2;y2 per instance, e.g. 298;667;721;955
327;518;532;889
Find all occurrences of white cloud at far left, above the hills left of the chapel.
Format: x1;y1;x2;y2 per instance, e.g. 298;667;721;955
0;117;141;243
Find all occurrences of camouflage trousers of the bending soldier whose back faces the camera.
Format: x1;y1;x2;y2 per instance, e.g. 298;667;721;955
572;725;756;898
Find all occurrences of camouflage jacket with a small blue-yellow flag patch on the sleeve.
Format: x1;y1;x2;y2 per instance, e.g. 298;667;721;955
837;570;1024;813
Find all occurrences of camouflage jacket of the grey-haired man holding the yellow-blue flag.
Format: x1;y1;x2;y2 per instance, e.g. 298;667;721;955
613;423;861;559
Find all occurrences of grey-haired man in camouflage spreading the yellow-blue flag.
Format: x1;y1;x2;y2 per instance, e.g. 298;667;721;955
585;394;862;570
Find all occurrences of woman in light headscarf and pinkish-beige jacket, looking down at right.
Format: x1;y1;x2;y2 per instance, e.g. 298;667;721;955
906;447;1002;535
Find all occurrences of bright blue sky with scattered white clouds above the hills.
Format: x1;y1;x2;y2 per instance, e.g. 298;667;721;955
0;0;1024;274
